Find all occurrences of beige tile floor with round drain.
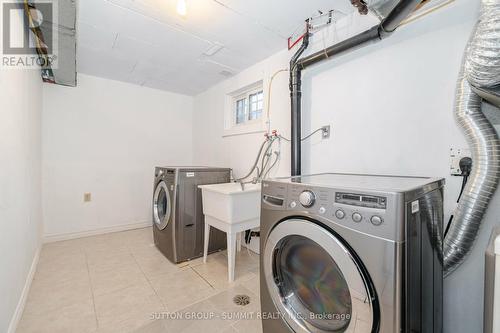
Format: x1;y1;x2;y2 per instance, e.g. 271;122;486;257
17;228;262;333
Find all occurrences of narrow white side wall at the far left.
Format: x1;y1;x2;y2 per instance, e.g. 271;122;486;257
0;64;42;332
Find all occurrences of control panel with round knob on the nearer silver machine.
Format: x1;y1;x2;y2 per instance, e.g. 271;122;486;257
262;181;404;241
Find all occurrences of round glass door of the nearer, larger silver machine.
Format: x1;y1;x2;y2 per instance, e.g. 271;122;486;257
263;219;379;333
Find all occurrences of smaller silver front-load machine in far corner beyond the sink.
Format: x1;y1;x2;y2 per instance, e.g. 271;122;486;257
153;167;231;263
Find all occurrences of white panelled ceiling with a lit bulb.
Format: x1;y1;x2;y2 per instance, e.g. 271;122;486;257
77;0;353;95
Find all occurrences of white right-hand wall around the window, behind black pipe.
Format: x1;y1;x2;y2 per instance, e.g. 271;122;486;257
194;0;500;333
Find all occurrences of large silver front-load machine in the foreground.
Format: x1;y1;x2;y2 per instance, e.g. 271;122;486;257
260;174;444;333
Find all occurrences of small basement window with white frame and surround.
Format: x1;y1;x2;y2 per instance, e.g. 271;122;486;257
224;81;264;136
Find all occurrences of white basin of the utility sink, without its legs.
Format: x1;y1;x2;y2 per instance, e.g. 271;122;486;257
199;183;260;223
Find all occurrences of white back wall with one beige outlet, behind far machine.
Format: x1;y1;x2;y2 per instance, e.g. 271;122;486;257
42;75;193;238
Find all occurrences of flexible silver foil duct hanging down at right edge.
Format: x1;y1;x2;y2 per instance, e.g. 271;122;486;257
443;0;500;276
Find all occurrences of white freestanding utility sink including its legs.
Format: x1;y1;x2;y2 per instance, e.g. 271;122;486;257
199;183;260;281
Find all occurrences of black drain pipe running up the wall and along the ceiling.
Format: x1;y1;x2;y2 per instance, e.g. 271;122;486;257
290;0;422;176
